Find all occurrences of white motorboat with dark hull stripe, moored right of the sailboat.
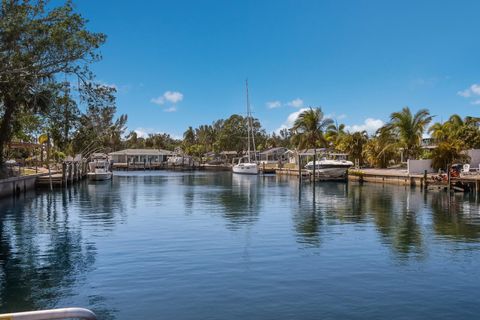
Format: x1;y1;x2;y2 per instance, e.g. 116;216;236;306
305;153;353;179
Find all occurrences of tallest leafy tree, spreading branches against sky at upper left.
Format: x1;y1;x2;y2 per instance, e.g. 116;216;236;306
0;0;105;175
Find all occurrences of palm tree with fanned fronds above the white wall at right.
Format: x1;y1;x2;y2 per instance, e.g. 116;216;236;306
387;107;433;159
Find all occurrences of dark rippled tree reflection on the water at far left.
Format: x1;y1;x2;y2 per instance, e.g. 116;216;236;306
0;194;96;312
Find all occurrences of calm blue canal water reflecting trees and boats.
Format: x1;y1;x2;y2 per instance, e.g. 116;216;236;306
0;172;480;319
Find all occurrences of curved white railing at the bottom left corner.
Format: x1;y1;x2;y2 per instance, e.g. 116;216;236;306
0;308;97;320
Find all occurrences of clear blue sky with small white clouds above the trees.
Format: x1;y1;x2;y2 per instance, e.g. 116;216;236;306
76;0;480;136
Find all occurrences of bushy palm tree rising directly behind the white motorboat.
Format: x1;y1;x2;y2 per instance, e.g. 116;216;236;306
292;108;333;149
